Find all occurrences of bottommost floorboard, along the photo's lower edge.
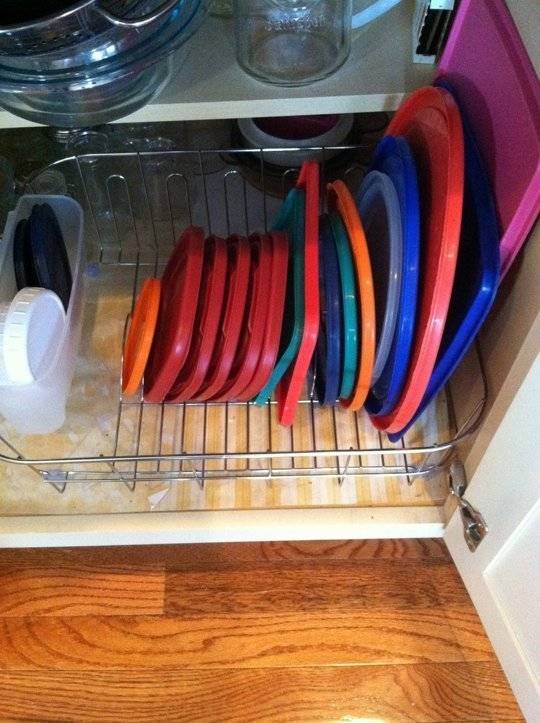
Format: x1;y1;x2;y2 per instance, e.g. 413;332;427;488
0;662;522;723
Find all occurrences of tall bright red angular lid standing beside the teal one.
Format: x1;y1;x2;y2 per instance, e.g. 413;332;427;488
276;161;319;425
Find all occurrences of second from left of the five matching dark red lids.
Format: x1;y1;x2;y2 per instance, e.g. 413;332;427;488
167;236;227;402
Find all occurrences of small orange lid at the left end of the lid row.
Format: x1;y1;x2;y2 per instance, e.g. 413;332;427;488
122;279;161;395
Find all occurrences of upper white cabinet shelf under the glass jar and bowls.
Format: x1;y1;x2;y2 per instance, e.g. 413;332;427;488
0;0;433;128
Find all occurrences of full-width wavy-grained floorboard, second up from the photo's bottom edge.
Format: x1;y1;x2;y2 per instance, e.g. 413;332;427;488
0;608;494;670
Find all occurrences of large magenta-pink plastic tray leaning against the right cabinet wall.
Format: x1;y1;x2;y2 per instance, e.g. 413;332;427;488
439;0;540;276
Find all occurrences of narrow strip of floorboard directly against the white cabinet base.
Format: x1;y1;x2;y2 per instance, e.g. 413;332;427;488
0;539;450;570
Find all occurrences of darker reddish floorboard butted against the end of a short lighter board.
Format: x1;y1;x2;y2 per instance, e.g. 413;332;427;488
165;559;472;617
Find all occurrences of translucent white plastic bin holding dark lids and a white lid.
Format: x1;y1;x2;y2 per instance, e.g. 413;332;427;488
0;196;84;434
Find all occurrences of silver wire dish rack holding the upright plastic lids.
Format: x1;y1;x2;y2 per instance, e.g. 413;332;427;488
0;146;487;491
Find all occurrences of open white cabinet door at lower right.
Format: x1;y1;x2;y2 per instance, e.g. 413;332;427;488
445;357;540;722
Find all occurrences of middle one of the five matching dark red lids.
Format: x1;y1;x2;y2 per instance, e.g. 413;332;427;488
195;236;251;401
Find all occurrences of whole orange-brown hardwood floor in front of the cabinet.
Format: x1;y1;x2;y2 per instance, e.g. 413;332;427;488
0;540;522;723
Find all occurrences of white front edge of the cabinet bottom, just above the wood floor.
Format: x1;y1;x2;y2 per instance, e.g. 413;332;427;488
0;507;446;548
